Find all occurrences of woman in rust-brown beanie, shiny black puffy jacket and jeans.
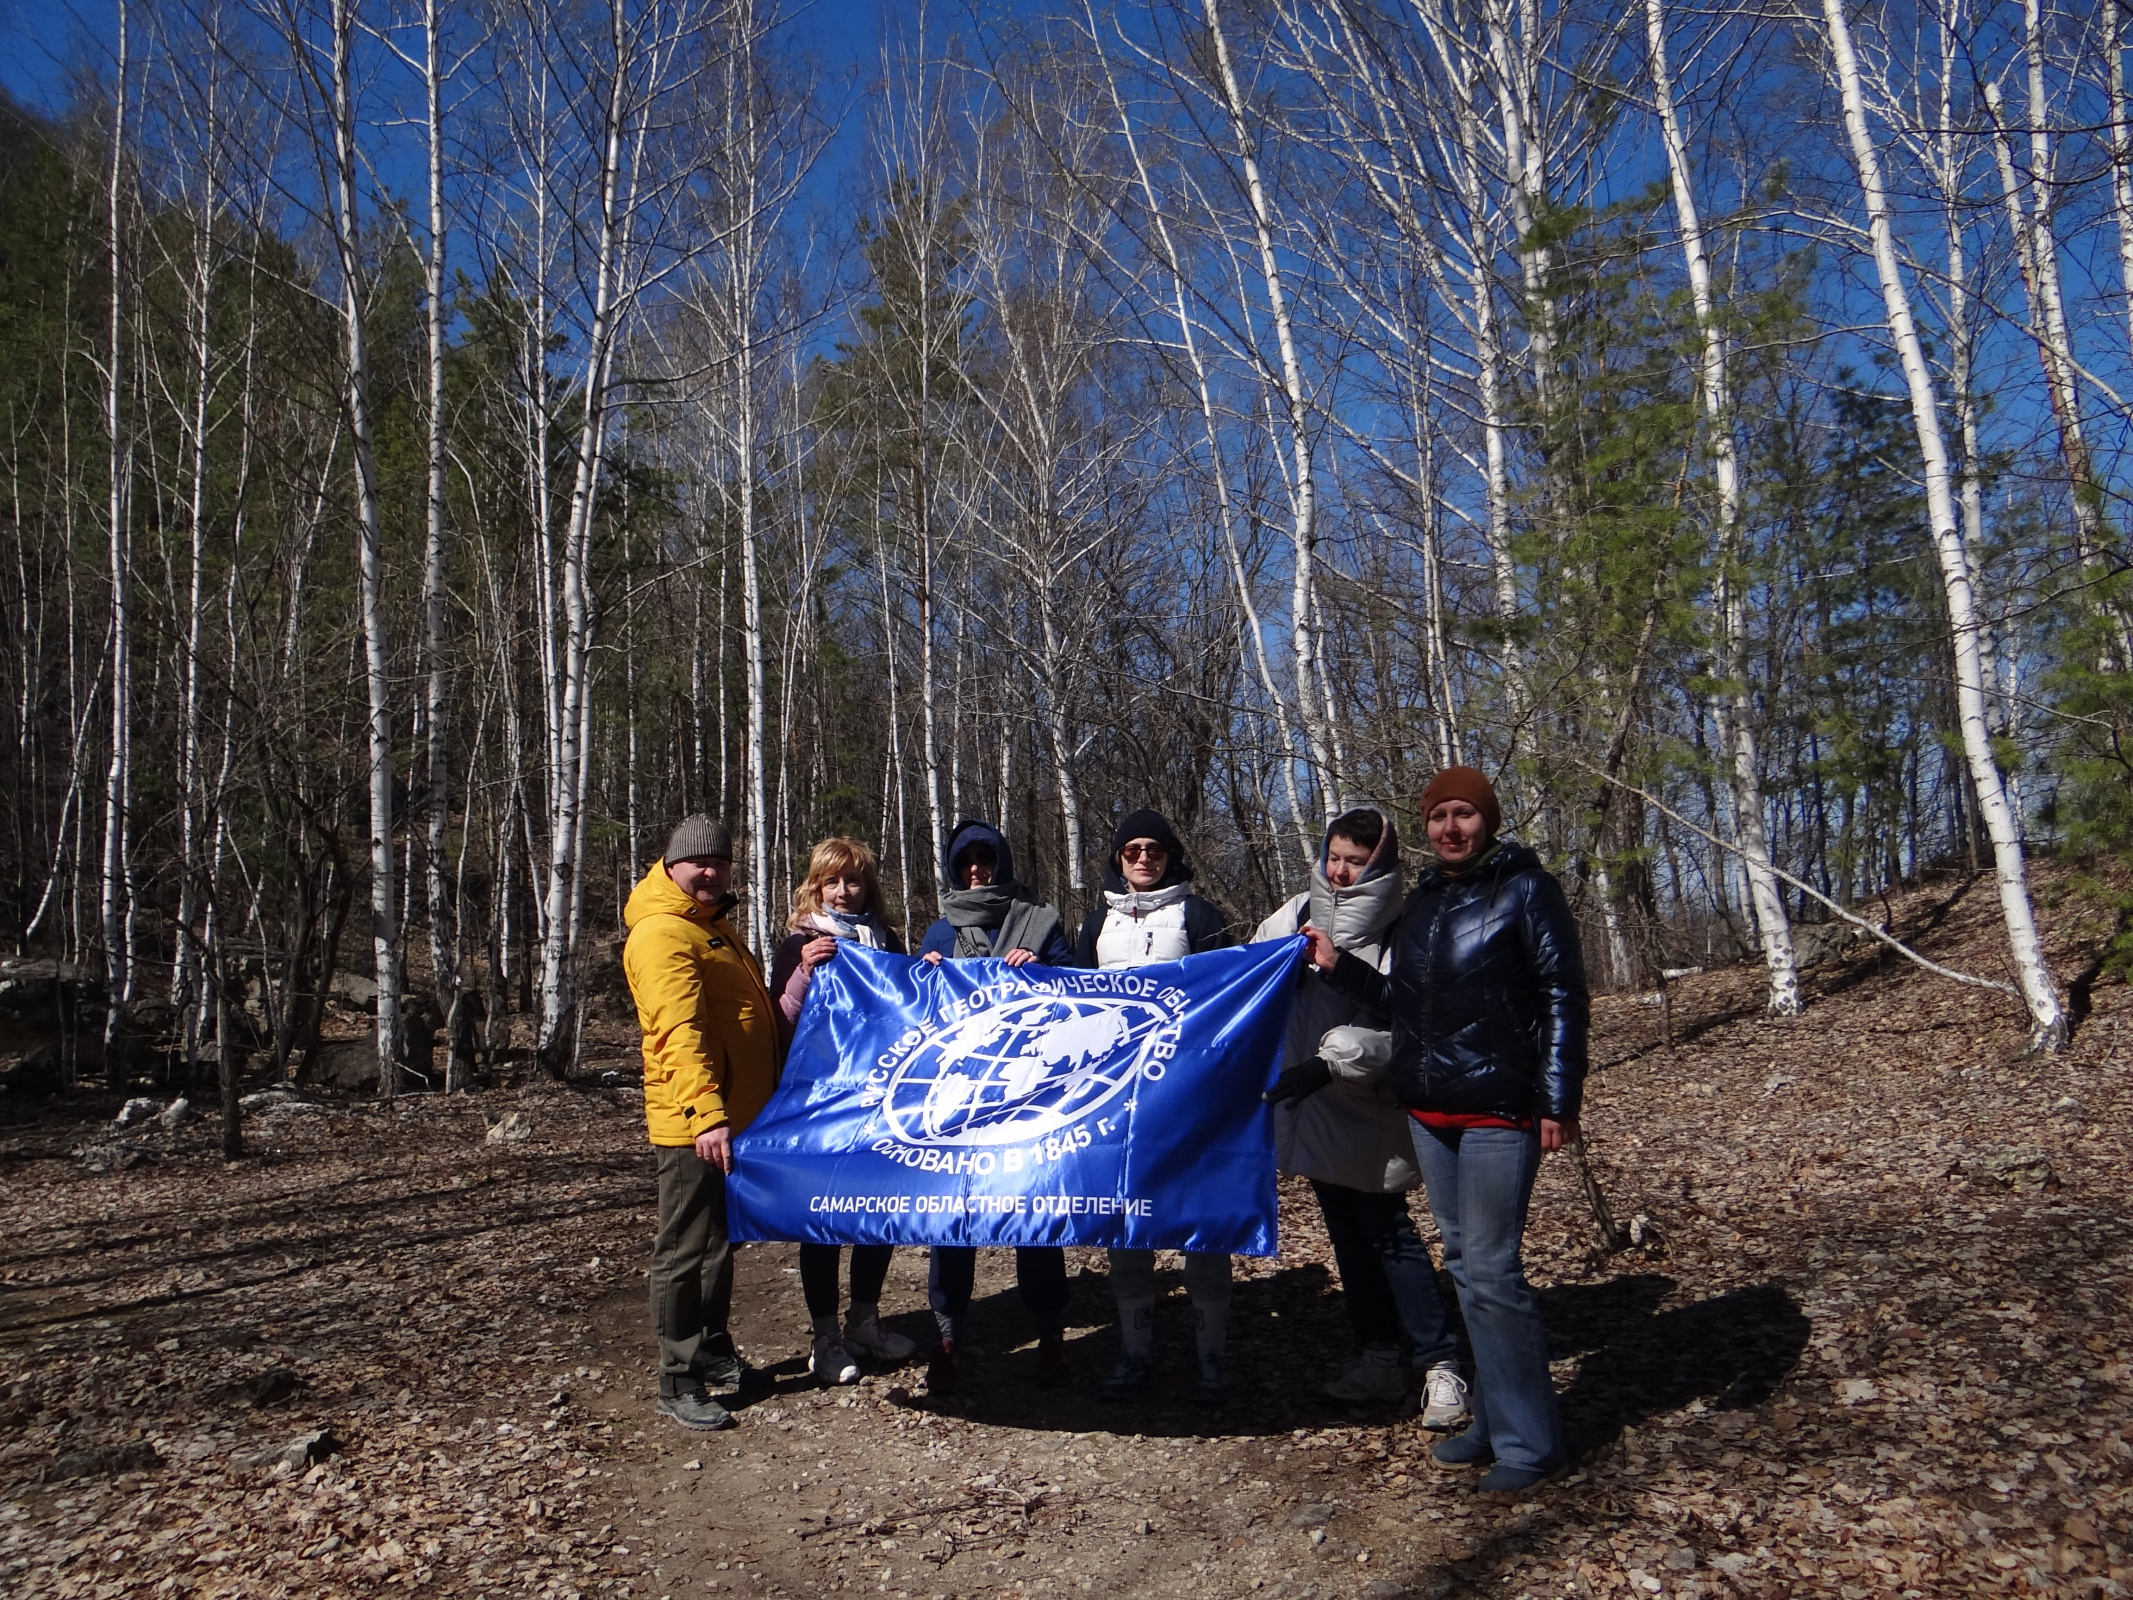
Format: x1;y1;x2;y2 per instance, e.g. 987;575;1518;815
1305;766;1591;1493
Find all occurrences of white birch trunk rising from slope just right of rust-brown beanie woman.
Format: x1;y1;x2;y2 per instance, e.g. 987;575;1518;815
1645;0;1800;1018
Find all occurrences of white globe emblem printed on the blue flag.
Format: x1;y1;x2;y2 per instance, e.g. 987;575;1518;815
881;994;1171;1146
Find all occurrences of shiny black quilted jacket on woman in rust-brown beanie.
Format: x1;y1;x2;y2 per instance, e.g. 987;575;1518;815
1331;838;1591;1120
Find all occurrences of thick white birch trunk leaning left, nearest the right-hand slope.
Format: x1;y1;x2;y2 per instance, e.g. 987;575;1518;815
1822;0;2067;1050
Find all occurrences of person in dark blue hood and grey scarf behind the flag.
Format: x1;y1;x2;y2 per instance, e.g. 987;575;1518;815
919;821;1073;1395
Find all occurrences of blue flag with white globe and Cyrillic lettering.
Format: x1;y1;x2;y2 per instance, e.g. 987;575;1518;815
727;939;1303;1257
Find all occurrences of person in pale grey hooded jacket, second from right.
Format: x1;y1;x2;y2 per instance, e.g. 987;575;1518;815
1252;806;1468;1431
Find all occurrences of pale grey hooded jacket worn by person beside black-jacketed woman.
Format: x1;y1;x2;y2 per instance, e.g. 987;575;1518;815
1252;811;1423;1195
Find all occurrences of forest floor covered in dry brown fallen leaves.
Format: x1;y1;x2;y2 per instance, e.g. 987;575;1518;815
0;868;2133;1600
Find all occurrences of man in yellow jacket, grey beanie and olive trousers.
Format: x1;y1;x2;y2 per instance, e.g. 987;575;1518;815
623;815;779;1427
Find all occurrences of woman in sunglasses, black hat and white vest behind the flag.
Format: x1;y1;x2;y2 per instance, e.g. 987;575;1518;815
1075;809;1231;1406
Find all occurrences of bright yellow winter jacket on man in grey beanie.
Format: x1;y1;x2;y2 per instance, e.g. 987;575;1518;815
623;862;779;1146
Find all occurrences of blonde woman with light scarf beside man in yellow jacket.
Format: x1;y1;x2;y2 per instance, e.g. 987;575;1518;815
770;838;917;1385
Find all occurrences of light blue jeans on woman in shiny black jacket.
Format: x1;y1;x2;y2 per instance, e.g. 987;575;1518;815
1414;1122;1566;1470
